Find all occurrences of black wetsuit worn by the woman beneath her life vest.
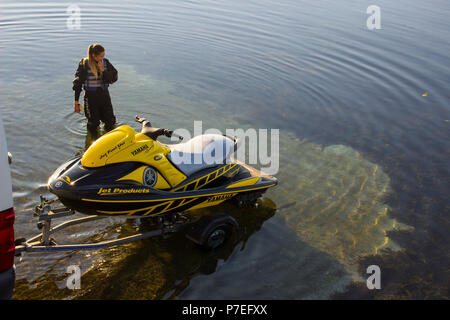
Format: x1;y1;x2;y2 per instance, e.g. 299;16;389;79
72;58;118;134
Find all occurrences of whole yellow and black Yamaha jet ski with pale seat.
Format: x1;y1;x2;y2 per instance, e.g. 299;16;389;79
48;116;277;217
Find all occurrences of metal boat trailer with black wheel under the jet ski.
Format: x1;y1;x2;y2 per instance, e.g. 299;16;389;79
15;195;238;256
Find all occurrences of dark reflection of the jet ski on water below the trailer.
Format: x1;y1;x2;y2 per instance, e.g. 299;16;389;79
78;198;276;299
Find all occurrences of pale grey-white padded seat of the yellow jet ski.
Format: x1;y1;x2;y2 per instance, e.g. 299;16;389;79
167;134;235;176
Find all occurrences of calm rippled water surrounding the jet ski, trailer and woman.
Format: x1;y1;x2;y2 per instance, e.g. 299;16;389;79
0;0;450;299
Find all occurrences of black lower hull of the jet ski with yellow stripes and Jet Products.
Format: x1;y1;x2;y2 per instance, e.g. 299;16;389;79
48;158;277;216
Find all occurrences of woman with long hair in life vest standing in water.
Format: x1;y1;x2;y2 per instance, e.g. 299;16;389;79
72;43;117;140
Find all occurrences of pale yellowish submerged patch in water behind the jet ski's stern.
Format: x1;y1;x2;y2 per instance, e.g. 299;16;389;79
275;137;410;276
